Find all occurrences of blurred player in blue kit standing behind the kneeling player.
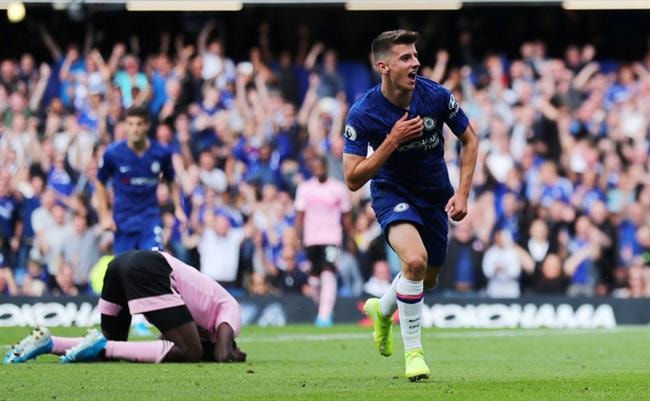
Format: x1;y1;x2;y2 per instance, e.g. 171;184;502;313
97;106;187;255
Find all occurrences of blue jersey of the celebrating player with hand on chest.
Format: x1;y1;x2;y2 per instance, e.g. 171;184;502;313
344;76;469;201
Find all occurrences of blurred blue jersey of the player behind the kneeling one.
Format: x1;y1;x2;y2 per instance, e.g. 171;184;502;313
97;141;174;232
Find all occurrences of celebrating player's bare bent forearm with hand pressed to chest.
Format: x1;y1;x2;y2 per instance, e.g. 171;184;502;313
343;112;423;191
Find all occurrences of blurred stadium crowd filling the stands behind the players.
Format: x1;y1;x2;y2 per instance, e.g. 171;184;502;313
0;23;650;297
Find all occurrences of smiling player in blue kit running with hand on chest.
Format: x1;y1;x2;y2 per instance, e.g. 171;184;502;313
343;30;478;381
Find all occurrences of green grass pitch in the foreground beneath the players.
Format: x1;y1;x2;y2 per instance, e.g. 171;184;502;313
0;325;650;401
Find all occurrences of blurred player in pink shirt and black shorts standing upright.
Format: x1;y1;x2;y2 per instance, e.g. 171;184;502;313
294;157;352;327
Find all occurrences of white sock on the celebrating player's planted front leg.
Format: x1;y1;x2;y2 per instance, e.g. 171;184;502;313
397;276;424;352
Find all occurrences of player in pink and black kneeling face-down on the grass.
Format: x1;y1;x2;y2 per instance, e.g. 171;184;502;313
3;250;246;363
